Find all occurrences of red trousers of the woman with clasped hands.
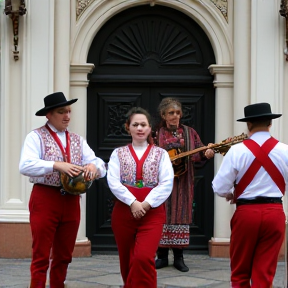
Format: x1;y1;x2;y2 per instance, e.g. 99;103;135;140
111;188;166;288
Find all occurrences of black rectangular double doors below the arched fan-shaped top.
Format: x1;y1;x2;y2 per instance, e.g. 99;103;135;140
87;84;214;250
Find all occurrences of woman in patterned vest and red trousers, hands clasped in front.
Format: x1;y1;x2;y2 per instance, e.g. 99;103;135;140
107;107;174;288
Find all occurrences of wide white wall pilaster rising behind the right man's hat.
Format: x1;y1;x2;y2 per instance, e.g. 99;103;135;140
250;0;287;137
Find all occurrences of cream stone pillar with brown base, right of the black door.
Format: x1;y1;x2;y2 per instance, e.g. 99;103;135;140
209;65;234;257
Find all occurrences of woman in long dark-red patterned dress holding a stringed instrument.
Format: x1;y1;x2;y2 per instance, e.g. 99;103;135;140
155;97;214;272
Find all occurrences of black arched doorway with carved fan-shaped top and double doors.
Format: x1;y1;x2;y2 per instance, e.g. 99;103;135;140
86;5;215;250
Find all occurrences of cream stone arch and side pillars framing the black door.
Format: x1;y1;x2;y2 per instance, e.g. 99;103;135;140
70;0;234;256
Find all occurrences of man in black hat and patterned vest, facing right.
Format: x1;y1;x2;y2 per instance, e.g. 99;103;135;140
19;92;106;288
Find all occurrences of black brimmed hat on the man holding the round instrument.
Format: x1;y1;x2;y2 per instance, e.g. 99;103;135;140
35;92;78;116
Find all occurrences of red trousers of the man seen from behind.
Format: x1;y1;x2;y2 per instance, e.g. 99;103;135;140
230;204;285;288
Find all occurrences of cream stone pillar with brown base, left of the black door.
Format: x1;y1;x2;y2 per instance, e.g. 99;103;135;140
70;63;94;257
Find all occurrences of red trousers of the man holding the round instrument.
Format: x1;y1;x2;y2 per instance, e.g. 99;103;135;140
29;184;80;288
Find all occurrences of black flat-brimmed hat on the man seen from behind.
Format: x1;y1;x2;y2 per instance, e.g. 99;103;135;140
237;103;282;122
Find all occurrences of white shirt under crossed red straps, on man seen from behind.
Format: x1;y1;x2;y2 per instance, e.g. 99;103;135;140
212;131;288;199
